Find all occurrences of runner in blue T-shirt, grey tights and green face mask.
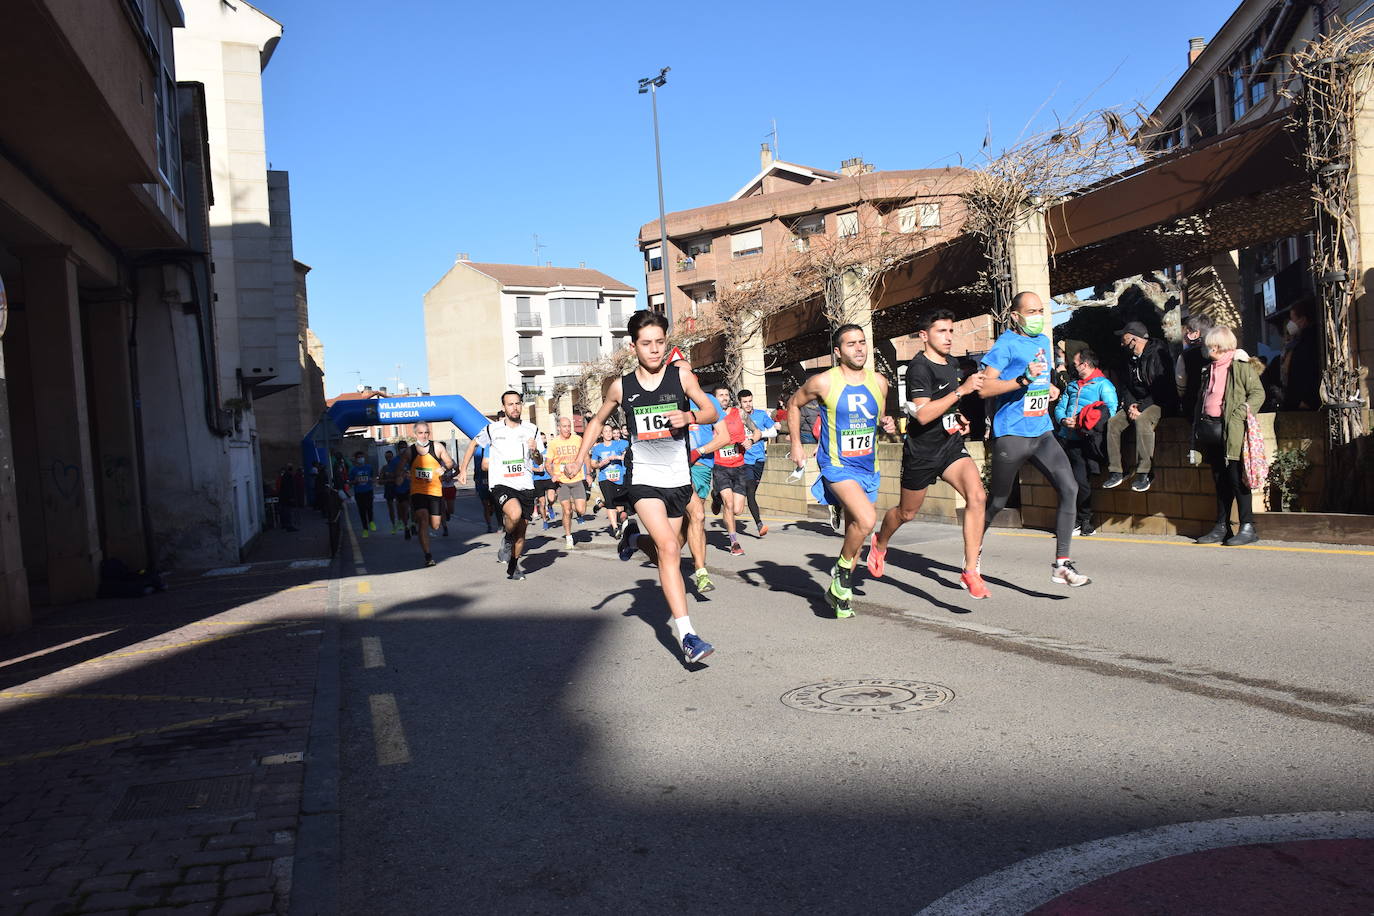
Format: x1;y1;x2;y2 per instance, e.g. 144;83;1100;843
980;293;1092;588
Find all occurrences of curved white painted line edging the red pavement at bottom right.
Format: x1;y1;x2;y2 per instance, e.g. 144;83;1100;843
916;810;1374;916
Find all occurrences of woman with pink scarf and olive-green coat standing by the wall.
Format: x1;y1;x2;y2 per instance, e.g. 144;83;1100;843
1193;327;1264;547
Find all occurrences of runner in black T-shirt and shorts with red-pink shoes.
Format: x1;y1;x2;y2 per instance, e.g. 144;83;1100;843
868;309;988;599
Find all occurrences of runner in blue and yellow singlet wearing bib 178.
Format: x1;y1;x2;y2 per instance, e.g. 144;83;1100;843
787;324;896;618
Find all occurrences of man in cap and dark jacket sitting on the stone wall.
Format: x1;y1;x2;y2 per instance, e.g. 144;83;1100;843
1102;321;1179;493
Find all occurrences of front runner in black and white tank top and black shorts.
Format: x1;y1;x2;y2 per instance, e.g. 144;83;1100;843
565;312;716;662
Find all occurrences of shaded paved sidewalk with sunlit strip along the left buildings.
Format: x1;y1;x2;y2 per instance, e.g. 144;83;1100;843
0;512;334;916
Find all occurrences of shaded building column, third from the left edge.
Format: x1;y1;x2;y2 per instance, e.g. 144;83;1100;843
85;302;147;570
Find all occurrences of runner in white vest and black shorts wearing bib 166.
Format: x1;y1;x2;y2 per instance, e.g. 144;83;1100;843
458;390;544;581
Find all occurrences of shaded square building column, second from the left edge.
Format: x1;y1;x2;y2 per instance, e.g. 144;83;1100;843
21;247;103;604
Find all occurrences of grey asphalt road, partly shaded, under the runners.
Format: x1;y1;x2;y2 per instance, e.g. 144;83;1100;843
329;493;1374;913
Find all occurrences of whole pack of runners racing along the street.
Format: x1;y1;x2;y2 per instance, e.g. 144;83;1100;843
343;300;1091;662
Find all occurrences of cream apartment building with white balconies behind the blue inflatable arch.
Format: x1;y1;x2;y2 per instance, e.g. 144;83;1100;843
425;255;636;438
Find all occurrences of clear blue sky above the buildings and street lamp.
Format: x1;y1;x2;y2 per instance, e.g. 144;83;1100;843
257;0;1237;396
